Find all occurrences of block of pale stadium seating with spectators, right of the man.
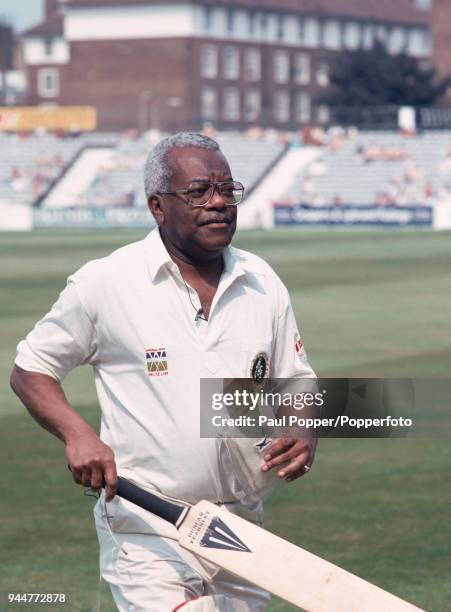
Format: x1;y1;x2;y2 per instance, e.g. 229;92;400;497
282;132;451;206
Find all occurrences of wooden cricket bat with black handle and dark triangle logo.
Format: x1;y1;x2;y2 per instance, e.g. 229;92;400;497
113;478;424;612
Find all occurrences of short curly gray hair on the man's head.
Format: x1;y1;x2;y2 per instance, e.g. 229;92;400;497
144;132;220;199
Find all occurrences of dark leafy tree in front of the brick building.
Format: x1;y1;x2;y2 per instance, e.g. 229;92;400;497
319;42;451;108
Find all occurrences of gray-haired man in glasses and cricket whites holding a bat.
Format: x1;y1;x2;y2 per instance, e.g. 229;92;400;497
11;133;314;612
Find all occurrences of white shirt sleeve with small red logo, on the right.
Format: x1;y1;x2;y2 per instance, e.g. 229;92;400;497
271;287;316;378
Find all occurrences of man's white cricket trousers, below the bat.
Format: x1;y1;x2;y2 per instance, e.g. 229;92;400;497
96;504;270;612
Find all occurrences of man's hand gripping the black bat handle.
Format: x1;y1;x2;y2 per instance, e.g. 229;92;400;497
66;434;117;501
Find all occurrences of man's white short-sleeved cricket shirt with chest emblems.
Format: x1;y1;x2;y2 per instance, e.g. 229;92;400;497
16;229;314;503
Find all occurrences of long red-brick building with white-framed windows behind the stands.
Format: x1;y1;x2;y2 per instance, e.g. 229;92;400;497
23;0;431;131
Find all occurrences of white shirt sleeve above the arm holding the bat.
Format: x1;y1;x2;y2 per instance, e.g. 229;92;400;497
15;277;97;382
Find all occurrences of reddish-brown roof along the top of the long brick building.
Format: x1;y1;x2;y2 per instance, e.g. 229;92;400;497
64;0;430;25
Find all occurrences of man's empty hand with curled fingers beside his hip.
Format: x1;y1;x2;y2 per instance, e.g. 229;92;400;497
262;437;317;482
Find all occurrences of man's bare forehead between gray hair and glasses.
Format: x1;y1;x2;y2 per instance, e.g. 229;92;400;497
168;147;230;178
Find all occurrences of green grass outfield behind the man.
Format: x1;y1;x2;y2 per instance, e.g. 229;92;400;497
0;230;451;612
